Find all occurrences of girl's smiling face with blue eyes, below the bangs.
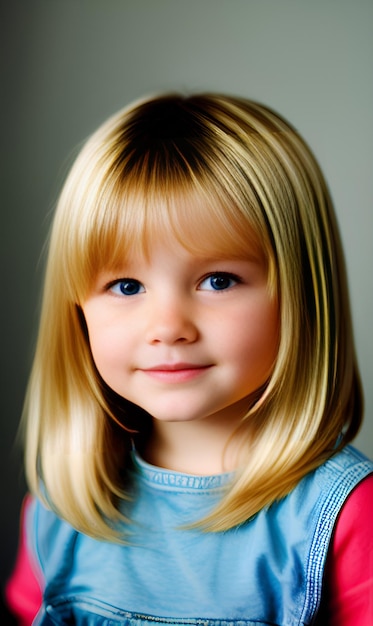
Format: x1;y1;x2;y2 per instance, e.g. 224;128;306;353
82;235;279;427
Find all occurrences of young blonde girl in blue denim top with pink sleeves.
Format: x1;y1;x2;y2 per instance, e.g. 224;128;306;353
7;95;373;626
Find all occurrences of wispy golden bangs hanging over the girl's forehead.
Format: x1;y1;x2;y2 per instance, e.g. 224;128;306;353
75;172;269;295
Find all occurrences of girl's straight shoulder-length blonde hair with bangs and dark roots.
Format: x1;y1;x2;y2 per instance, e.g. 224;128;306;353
25;94;362;540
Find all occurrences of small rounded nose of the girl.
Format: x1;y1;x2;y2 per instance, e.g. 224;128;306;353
146;299;198;345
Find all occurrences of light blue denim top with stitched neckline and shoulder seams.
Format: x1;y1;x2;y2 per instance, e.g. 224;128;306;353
28;447;373;626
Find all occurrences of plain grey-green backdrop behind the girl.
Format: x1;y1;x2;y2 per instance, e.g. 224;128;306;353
0;0;373;604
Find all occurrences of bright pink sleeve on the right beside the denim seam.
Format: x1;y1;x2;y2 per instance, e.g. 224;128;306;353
325;475;373;626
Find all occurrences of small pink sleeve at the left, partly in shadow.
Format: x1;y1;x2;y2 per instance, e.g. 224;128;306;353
5;496;42;626
